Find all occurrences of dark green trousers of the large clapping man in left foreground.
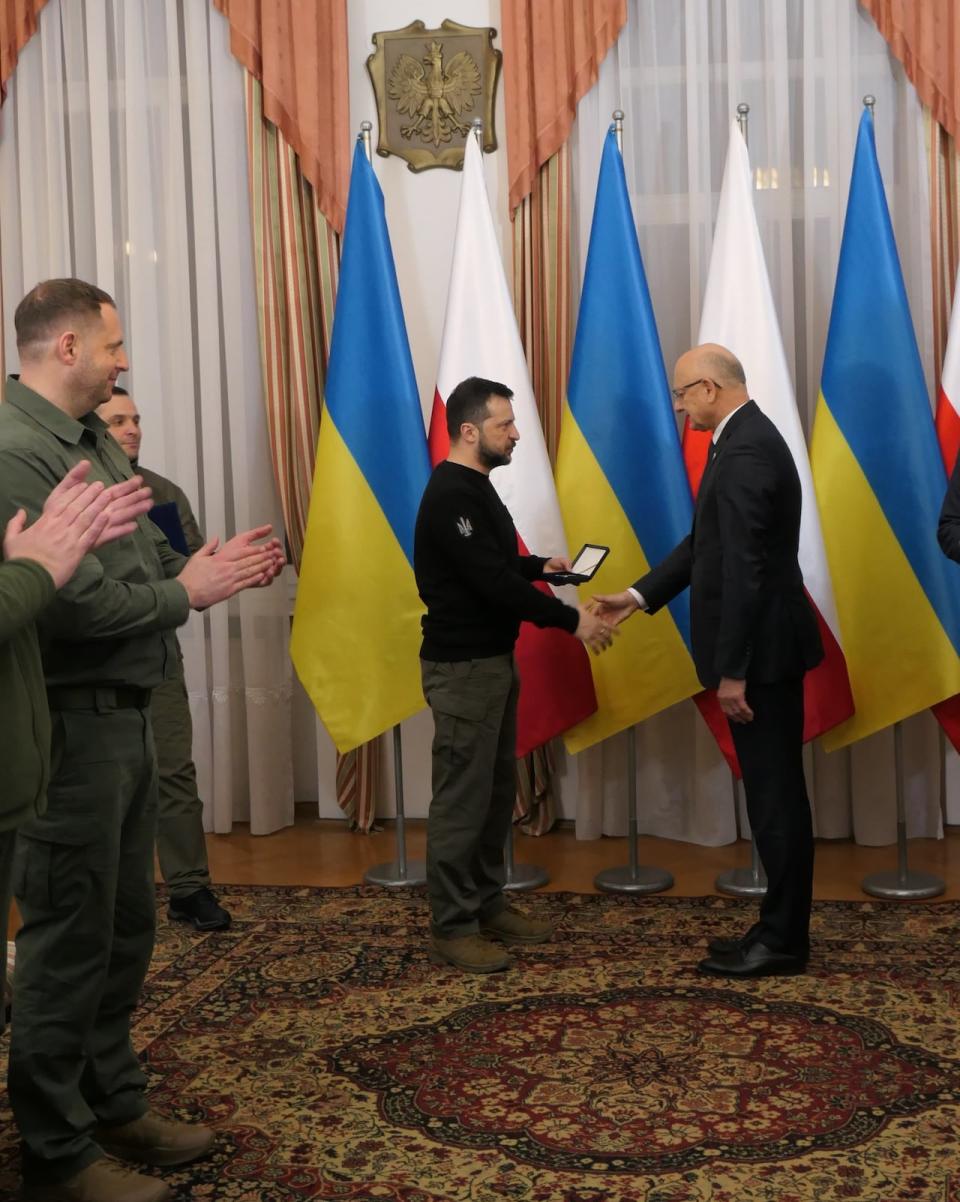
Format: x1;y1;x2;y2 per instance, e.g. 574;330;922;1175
8;708;156;1184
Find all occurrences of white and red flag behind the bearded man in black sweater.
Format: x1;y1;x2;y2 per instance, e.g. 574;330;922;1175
429;136;597;756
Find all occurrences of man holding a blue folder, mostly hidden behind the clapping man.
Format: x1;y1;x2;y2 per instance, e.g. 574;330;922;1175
97;385;229;930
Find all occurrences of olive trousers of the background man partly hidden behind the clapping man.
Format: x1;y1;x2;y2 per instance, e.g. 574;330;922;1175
150;659;210;898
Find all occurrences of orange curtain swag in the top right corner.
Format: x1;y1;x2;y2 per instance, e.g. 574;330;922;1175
860;0;960;138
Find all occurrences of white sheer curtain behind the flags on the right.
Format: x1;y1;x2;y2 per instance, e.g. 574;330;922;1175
572;0;960;844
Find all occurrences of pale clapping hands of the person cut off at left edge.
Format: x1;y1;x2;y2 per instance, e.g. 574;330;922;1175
4;460;133;589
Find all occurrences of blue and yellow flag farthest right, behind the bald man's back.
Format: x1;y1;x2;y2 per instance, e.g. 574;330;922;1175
810;111;960;749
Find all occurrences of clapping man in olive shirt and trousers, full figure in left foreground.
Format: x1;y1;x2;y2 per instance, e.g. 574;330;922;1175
0;280;282;1202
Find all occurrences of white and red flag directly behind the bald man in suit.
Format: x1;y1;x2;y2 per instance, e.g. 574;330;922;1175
684;121;853;758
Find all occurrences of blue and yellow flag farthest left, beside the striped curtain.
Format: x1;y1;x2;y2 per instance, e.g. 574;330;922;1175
291;143;430;751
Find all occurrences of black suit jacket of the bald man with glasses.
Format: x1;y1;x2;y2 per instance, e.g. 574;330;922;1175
633;400;823;689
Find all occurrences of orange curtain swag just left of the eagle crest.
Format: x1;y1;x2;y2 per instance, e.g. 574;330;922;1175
214;0;353;233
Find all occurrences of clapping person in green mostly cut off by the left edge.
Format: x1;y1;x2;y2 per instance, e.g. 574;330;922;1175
0;463;150;1031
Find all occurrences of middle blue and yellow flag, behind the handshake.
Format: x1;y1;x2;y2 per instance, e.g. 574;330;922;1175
556;132;702;751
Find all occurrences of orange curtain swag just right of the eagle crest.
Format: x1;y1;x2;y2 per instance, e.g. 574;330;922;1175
501;0;627;213
